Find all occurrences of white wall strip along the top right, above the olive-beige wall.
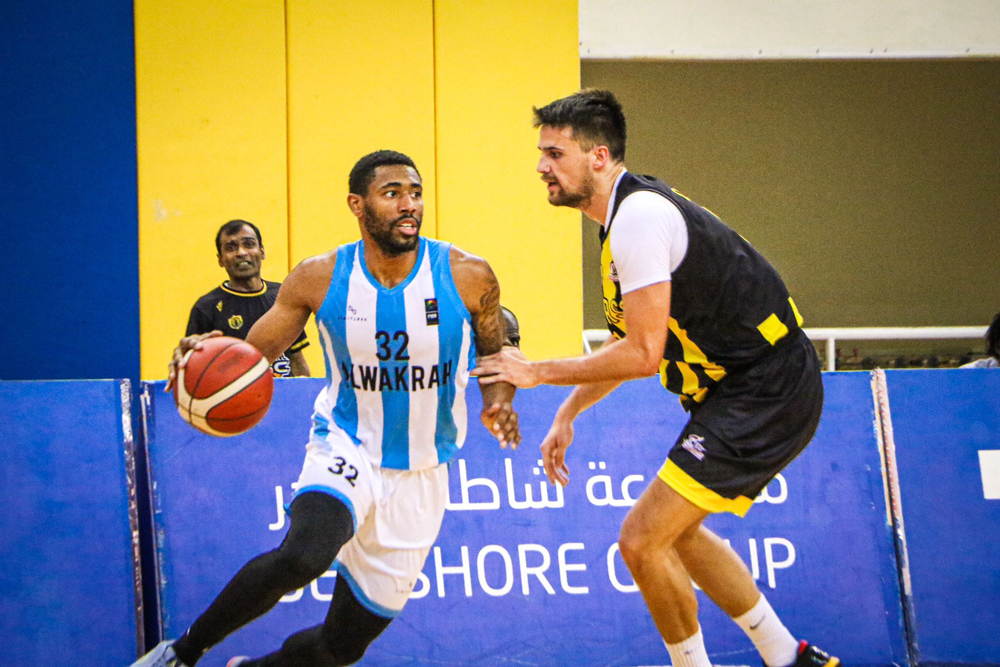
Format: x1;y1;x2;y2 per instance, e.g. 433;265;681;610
580;0;1000;59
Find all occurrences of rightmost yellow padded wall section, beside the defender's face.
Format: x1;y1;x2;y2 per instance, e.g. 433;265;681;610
435;0;583;358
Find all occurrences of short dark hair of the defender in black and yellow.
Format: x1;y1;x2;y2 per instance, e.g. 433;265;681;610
532;88;626;162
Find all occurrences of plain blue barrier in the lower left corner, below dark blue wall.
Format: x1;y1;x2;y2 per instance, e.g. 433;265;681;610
0;380;142;667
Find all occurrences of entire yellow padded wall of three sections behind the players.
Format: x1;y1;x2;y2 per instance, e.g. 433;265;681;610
141;0;581;377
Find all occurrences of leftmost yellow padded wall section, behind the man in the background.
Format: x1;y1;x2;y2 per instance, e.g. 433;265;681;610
135;0;288;378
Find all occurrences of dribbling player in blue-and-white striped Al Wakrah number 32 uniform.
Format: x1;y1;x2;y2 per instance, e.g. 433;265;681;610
135;151;521;667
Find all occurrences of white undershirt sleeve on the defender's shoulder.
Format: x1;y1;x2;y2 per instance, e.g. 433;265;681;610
608;190;688;294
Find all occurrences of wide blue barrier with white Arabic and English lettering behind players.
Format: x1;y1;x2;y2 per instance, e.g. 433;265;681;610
144;373;908;667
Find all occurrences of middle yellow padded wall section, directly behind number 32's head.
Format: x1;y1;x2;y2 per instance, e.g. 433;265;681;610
288;0;436;376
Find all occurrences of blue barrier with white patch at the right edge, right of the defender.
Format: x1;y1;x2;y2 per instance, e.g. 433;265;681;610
885;369;1000;665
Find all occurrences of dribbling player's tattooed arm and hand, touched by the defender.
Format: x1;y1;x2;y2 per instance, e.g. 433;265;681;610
451;247;521;448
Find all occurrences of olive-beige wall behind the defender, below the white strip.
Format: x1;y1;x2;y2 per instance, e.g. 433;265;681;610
582;60;1000;349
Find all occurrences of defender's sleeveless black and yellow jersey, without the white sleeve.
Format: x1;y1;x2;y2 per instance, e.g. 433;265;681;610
600;171;802;409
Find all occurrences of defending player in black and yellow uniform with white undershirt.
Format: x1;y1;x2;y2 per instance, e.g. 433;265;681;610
473;90;839;667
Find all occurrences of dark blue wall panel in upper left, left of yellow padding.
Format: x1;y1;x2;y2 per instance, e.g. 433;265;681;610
0;0;139;381
